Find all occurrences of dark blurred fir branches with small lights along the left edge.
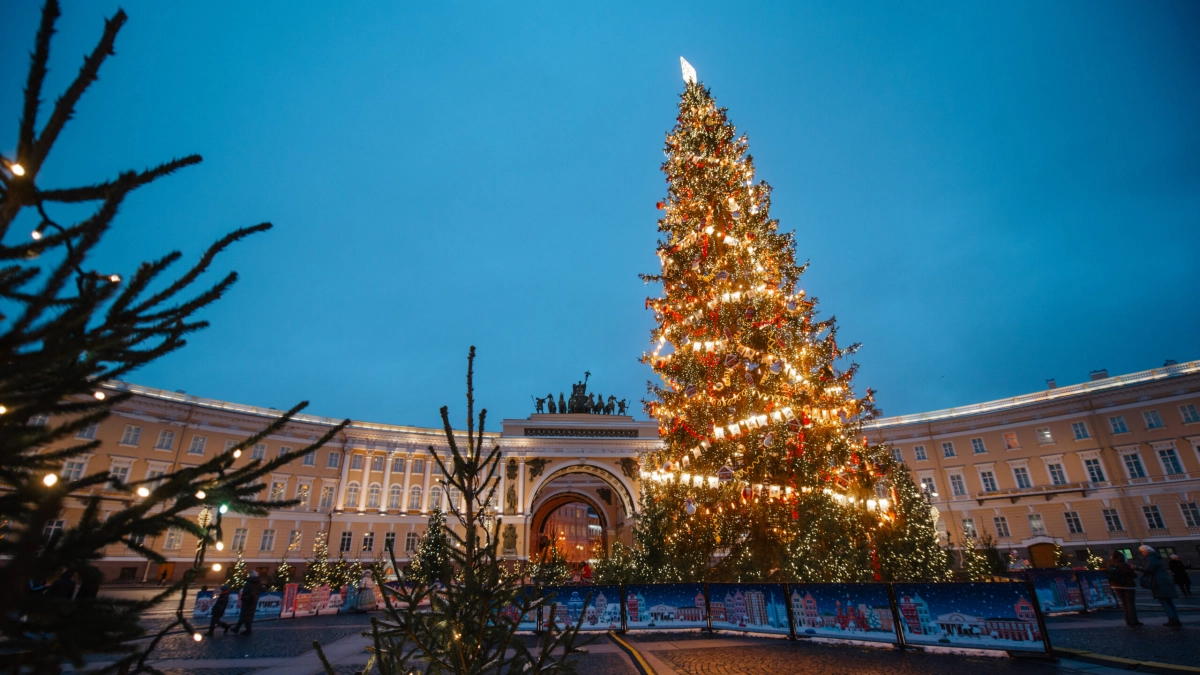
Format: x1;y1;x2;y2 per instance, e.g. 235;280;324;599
0;0;346;673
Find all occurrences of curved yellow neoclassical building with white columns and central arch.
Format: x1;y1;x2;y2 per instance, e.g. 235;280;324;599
34;362;1200;583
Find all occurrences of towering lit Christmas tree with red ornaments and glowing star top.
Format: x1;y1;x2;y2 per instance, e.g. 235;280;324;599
636;61;948;581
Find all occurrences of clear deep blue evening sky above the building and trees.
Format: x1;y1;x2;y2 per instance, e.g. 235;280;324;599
0;0;1200;429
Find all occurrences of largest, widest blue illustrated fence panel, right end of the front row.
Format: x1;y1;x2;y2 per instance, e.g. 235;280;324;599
893;583;1049;652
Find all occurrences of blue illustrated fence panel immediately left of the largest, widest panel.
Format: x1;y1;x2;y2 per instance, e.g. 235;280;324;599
787;584;900;645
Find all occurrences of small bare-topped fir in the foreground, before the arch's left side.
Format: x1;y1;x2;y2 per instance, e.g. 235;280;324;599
313;347;583;675
